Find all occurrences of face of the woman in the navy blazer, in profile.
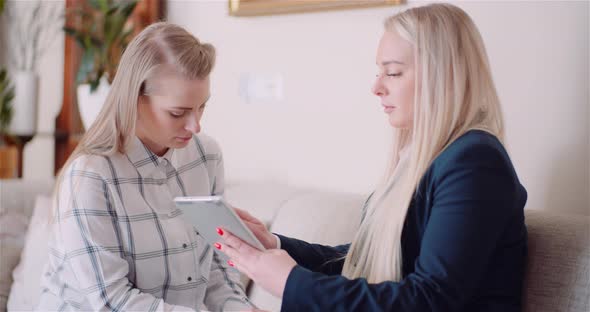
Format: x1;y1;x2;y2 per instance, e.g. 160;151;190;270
372;31;416;128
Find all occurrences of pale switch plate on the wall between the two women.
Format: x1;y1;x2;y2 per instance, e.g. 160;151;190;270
239;73;283;103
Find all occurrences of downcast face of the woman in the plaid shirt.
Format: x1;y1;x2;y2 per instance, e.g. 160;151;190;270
136;73;210;156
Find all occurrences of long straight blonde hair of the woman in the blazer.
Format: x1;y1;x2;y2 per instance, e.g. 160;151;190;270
342;4;504;283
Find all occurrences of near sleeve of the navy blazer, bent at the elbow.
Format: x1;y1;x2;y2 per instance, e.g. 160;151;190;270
282;145;520;311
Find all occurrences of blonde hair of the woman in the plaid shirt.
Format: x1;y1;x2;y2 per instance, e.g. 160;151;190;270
54;22;215;211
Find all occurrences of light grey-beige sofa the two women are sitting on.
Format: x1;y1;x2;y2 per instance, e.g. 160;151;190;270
0;180;590;312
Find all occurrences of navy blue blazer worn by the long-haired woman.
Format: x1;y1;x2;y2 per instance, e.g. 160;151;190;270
279;130;527;312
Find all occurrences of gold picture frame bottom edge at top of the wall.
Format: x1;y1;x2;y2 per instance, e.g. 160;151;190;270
228;0;403;16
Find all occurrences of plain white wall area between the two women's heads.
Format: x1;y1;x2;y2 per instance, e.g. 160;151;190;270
168;1;392;192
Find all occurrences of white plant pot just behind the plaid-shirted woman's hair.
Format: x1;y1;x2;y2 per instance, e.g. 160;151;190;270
76;77;111;130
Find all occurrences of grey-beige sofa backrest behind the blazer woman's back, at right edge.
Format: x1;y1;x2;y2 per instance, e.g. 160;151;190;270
523;210;590;312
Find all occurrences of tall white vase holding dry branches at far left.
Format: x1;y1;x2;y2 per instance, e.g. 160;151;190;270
9;71;39;135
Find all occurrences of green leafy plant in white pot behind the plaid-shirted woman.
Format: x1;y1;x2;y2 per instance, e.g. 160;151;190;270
64;0;137;129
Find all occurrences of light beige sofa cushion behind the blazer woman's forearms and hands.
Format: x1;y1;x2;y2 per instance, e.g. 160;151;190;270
249;190;366;311
